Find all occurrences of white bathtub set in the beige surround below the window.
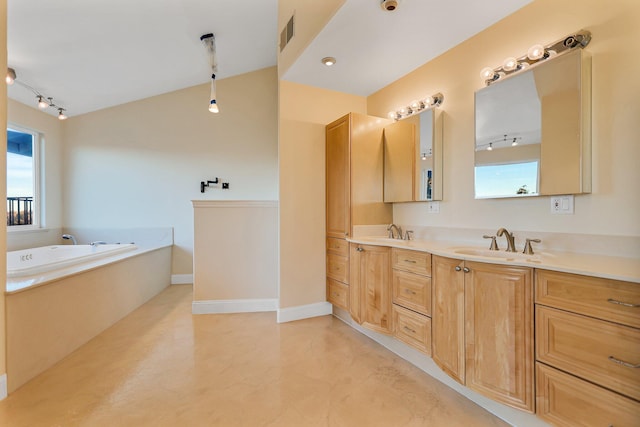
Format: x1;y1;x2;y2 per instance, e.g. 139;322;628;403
7;243;137;279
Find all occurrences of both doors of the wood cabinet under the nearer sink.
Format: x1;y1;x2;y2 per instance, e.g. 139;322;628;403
432;256;534;412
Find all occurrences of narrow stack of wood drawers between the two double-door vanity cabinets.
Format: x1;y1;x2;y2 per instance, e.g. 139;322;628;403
391;248;431;355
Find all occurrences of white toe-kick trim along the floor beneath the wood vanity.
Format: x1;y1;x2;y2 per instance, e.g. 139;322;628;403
333;307;550;427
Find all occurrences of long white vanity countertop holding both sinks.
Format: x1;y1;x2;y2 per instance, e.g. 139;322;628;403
348;236;640;283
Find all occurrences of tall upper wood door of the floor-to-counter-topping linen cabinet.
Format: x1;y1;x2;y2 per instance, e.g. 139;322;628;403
326;115;351;239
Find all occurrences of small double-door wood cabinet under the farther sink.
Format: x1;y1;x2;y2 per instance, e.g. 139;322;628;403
349;243;392;334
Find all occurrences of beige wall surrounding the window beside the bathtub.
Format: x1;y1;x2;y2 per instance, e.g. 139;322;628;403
3;99;64;251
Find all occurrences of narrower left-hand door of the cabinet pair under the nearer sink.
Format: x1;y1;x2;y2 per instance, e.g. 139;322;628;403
431;256;465;384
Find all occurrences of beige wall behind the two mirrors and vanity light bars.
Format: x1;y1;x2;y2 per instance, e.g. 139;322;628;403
368;0;640;236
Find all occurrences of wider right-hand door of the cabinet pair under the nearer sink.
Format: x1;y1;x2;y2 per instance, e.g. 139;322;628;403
464;262;535;412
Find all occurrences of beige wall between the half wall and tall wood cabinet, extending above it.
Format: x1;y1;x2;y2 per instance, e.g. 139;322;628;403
279;81;366;308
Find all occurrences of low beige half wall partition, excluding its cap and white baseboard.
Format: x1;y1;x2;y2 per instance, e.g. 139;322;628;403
193;200;278;301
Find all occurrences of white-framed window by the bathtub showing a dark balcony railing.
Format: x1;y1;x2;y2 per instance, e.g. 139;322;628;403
7;126;40;230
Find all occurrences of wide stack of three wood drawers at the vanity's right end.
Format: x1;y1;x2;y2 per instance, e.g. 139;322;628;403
535;269;640;426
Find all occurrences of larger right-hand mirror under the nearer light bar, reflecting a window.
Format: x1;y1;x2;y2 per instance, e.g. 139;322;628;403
475;49;591;198
